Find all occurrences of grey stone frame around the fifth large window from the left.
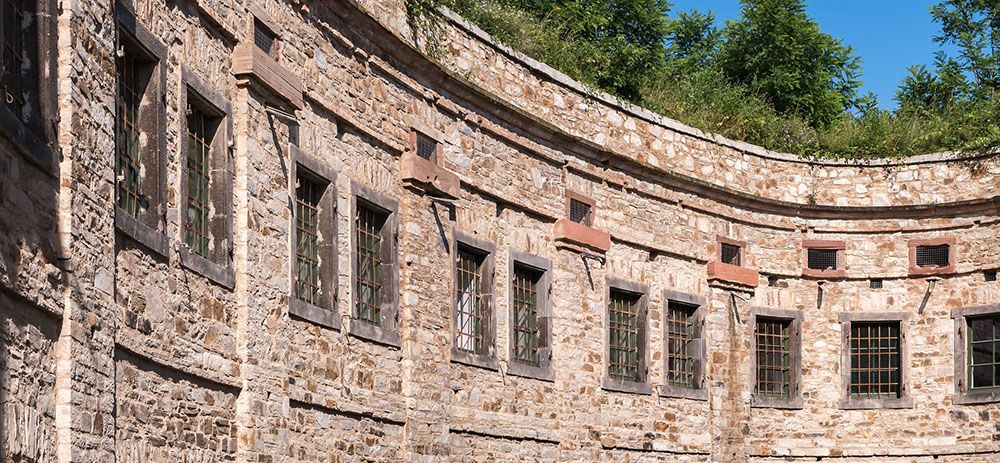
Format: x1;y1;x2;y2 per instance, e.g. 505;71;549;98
348;181;400;348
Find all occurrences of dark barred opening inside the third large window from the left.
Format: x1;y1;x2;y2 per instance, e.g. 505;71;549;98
184;105;221;258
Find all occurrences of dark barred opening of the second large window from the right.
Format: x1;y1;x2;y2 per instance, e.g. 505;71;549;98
849;322;902;399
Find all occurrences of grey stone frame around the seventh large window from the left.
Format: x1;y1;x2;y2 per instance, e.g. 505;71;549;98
507;249;555;381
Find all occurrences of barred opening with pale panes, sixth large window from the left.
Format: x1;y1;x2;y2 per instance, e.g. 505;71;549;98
455;247;489;354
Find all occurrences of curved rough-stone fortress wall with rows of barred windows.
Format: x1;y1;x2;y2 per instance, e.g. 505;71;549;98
0;0;1000;463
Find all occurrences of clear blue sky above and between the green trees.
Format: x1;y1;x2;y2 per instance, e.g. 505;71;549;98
670;0;952;109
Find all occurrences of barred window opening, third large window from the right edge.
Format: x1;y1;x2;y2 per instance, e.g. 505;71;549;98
754;317;794;399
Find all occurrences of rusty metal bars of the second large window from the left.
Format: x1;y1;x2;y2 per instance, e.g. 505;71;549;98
115;51;143;219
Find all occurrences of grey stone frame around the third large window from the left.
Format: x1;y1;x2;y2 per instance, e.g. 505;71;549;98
177;66;236;289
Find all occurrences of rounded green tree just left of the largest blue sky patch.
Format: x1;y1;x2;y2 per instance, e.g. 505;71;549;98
719;0;861;127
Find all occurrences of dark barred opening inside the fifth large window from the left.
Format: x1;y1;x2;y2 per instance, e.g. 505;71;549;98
354;200;389;326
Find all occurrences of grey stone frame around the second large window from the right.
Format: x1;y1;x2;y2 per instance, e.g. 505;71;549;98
837;312;913;410
